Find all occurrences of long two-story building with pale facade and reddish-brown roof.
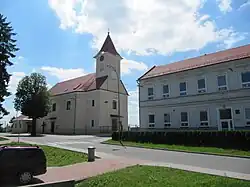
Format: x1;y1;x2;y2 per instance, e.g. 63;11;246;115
138;45;250;130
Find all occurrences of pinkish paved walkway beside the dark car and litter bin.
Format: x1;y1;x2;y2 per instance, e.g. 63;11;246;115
37;157;143;183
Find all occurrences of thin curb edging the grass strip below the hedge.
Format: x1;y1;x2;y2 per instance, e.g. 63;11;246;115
101;142;250;159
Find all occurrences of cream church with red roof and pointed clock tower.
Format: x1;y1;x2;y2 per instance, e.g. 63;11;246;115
37;33;128;134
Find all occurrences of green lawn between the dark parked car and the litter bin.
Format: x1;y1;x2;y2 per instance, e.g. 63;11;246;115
0;142;88;167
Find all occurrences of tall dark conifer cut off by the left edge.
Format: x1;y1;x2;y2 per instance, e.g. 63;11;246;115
0;14;19;119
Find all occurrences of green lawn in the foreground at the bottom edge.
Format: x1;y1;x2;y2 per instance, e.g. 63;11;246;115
76;166;250;187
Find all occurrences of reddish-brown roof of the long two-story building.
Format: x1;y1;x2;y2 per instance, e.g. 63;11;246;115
138;45;250;80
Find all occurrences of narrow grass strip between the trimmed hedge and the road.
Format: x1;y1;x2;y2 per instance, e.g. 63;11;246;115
103;140;250;158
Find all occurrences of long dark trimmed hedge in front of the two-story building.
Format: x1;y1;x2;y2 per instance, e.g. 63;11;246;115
112;131;250;151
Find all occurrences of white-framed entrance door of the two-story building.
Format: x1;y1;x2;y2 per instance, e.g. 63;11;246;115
219;108;234;131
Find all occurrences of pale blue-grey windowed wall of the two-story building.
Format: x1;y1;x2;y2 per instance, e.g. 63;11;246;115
139;59;250;128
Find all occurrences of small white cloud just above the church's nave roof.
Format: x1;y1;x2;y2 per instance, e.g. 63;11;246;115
41;66;86;81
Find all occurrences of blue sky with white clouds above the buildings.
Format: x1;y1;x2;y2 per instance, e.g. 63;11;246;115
0;0;250;125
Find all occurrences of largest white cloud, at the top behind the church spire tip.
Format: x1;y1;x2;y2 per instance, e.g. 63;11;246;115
49;0;243;55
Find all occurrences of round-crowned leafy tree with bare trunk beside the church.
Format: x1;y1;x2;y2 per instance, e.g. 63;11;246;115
14;73;50;136
